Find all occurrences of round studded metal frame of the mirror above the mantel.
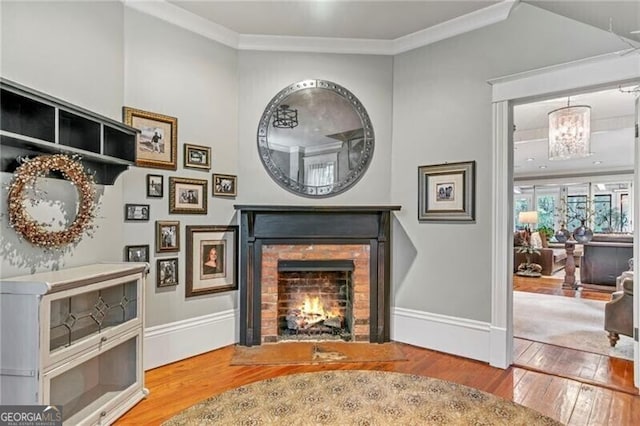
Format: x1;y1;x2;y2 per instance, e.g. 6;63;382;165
258;80;375;198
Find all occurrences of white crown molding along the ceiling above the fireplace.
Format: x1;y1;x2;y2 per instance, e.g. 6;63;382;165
121;0;520;55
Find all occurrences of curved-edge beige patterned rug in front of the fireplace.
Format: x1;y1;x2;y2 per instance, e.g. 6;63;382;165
164;371;561;426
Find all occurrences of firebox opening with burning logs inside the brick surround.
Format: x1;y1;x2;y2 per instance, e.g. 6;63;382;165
278;260;354;341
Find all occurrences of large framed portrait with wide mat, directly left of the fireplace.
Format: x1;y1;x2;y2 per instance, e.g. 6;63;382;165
185;225;238;297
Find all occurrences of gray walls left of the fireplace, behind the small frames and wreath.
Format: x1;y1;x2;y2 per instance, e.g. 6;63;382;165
0;1;238;326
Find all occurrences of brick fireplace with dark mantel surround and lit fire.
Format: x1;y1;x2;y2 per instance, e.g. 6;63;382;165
235;205;399;346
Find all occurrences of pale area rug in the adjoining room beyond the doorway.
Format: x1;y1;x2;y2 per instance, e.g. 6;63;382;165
513;291;633;360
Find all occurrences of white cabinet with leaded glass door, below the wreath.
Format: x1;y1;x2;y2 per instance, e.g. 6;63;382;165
0;263;148;425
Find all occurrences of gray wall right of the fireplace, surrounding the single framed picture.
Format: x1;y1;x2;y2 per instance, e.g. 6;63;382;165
391;4;621;321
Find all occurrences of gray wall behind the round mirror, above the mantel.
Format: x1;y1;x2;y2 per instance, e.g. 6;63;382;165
238;51;393;205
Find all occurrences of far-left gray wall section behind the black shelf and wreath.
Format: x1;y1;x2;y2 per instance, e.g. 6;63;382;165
0;2;124;277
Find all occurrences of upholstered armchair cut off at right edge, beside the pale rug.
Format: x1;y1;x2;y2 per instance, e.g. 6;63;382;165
604;271;633;346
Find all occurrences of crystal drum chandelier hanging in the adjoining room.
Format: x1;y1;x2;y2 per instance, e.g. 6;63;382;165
549;98;591;160
